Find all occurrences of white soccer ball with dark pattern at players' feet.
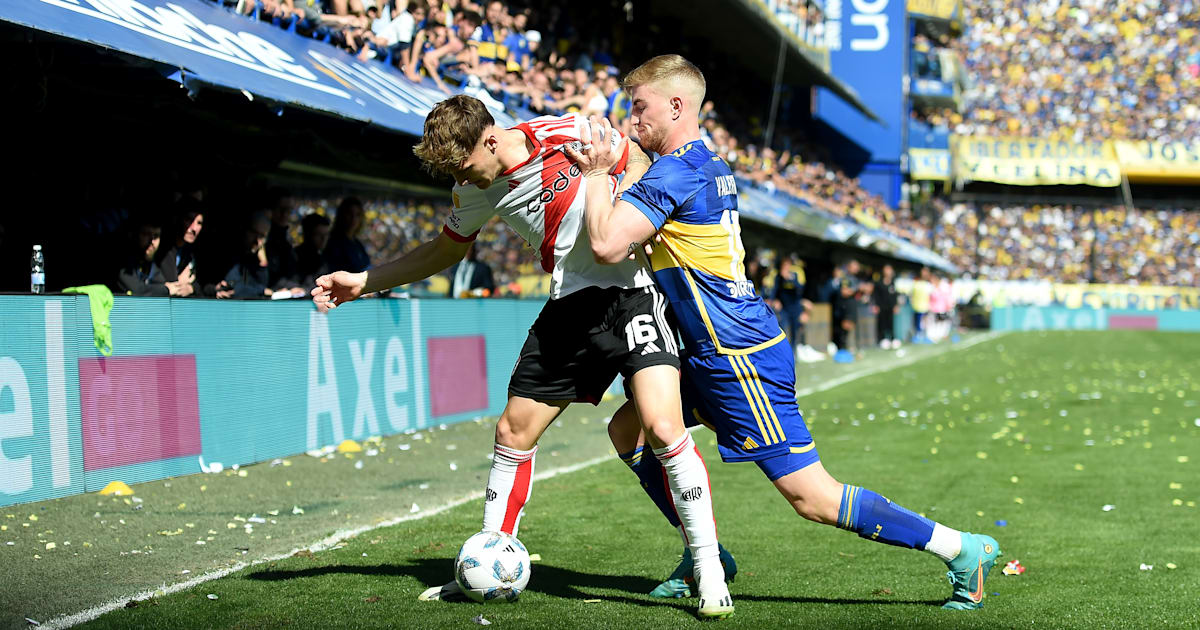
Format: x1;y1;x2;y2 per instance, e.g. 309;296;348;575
454;532;530;602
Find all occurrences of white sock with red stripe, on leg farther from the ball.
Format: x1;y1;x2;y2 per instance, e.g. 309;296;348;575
654;432;727;599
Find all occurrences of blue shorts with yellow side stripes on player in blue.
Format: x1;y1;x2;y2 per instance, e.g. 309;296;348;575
680;336;820;481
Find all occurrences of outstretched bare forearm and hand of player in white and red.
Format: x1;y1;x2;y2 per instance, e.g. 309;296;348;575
312;232;470;311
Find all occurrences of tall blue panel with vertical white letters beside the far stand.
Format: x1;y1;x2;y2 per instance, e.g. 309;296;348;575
816;0;908;163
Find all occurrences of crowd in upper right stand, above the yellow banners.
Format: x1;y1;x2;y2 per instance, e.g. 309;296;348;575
953;0;1200;142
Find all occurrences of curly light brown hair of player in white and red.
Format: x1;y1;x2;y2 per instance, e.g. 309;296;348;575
413;94;496;175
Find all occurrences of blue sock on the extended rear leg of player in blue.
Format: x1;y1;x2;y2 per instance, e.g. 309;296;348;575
838;484;934;550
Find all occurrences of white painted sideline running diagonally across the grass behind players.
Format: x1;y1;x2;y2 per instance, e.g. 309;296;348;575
42;332;1007;630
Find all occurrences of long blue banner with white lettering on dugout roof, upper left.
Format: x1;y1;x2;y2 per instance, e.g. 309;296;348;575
0;0;517;136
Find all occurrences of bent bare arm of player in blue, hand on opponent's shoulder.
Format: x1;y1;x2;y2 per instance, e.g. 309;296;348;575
564;116;658;264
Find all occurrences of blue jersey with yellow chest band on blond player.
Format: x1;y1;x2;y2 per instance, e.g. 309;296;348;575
622;140;784;356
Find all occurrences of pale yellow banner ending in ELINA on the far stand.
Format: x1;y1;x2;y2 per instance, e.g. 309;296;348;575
952;136;1121;187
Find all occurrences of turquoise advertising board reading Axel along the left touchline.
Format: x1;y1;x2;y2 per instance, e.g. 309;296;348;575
0;295;541;505
